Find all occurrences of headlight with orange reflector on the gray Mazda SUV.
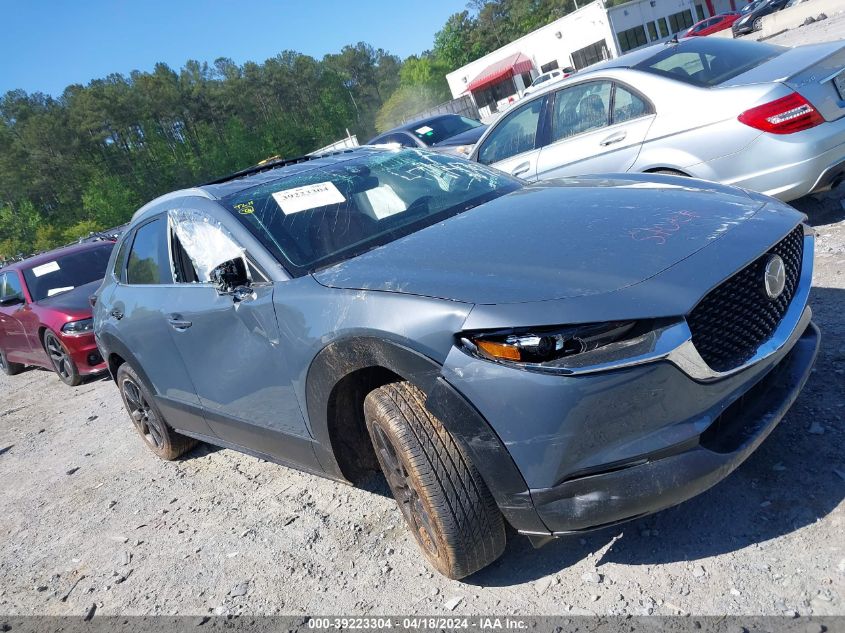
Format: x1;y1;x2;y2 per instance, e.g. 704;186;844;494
461;321;643;365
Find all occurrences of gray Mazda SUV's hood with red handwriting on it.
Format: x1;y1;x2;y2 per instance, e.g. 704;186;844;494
314;174;768;304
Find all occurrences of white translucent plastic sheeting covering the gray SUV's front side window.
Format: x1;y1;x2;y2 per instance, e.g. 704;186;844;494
168;209;244;283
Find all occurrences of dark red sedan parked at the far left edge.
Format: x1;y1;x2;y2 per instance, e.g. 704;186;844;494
0;241;114;386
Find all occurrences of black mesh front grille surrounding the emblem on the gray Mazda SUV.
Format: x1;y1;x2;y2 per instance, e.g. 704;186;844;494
687;225;804;371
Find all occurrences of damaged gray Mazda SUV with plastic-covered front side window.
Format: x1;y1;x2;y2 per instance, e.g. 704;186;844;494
94;148;819;578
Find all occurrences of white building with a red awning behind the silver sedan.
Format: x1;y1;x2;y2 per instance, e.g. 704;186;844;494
446;0;748;117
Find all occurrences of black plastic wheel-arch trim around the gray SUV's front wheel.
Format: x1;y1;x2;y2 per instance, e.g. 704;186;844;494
305;337;549;534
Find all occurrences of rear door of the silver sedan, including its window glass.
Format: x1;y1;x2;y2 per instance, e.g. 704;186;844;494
537;80;655;180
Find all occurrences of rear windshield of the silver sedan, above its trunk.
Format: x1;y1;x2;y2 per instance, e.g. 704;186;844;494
634;38;786;88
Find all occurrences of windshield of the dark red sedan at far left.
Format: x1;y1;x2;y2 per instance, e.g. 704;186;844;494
23;242;114;301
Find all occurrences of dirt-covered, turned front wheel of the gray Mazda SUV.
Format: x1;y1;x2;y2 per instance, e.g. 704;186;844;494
364;382;506;580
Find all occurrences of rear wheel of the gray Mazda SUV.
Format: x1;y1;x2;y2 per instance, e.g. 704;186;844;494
115;363;198;461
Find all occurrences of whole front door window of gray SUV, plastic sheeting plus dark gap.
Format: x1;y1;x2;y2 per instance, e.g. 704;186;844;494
167;209;250;283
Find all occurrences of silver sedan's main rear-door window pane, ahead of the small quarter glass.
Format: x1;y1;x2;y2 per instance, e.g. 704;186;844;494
552;81;613;141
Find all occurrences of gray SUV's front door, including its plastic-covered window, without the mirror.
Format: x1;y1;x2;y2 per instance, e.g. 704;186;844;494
161;209;318;468
